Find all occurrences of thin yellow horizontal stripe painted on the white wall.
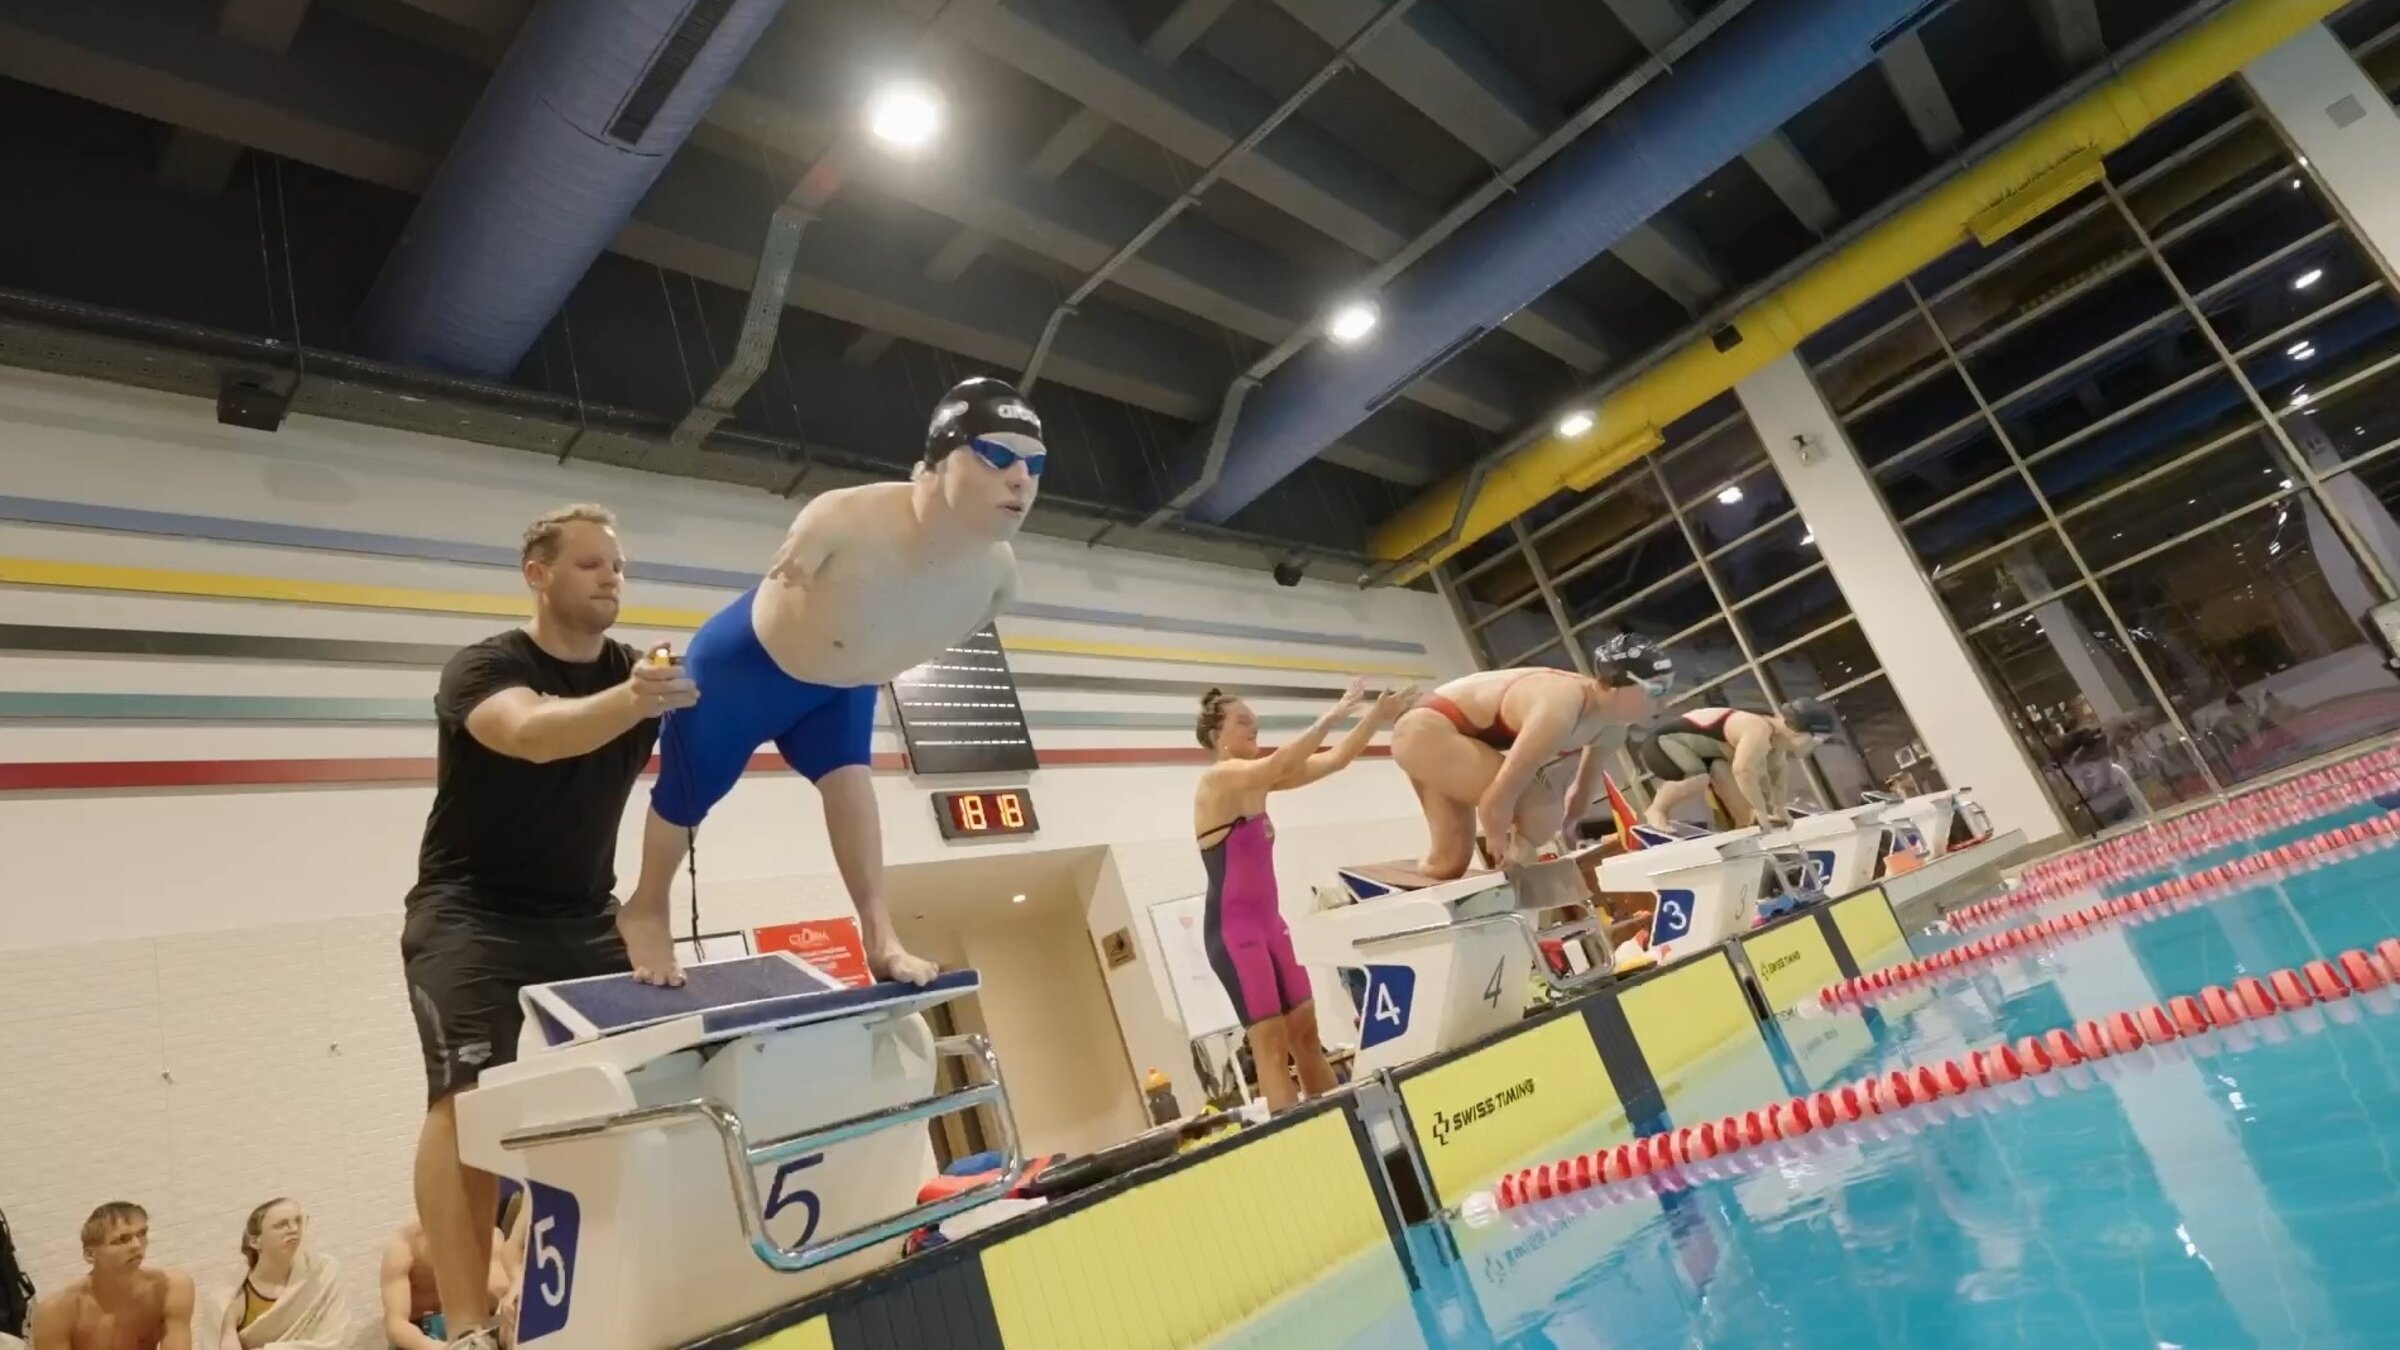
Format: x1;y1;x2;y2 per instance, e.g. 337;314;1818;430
0;557;1433;677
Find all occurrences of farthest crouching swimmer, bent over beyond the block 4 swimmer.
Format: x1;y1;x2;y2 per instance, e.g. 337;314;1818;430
1634;699;1841;829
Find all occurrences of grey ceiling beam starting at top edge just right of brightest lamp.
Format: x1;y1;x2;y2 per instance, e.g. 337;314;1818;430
873;0;1589;379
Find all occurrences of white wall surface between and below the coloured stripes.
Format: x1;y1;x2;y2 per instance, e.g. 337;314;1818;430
0;372;1471;1326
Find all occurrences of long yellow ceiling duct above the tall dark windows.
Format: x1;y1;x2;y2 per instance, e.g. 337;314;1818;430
1370;0;2342;571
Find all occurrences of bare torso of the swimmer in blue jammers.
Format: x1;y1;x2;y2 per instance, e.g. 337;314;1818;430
751;483;1018;689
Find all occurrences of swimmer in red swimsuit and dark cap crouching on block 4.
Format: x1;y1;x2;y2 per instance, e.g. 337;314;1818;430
1392;634;1675;882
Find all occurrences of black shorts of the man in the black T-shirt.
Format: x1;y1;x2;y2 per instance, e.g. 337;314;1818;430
401;898;634;1103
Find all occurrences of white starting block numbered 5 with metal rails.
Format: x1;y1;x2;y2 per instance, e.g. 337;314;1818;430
458;954;1025;1350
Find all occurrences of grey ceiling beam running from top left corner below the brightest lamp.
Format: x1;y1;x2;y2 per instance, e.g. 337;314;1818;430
0;0;1447;483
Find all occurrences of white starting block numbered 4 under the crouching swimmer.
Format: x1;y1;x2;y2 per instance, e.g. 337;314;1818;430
1291;850;1610;1074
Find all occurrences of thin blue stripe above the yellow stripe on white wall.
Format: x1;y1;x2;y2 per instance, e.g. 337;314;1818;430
0;495;1426;656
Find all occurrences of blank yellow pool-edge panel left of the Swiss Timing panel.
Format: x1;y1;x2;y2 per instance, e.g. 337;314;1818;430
982;1112;1399;1350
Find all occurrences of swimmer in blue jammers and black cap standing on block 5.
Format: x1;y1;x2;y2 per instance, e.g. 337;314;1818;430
619;377;1046;985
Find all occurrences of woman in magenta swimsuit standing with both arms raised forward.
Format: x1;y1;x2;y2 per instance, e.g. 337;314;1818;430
1193;680;1416;1110
